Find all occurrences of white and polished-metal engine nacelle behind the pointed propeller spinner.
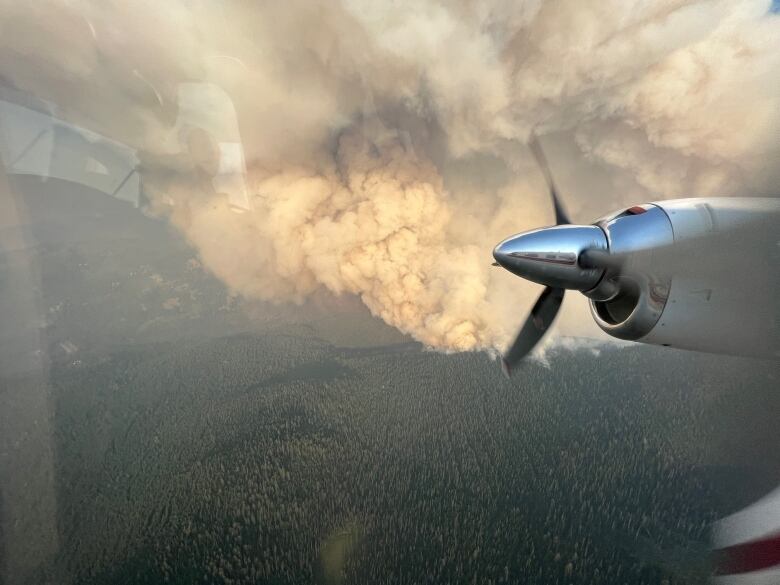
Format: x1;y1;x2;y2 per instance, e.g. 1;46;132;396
584;198;780;357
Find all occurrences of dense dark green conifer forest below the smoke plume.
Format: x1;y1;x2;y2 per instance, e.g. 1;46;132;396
42;334;774;585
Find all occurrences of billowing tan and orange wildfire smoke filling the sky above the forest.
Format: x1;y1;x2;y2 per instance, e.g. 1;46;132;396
0;0;780;350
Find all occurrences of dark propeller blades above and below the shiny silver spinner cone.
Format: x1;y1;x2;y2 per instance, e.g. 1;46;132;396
501;135;571;377
